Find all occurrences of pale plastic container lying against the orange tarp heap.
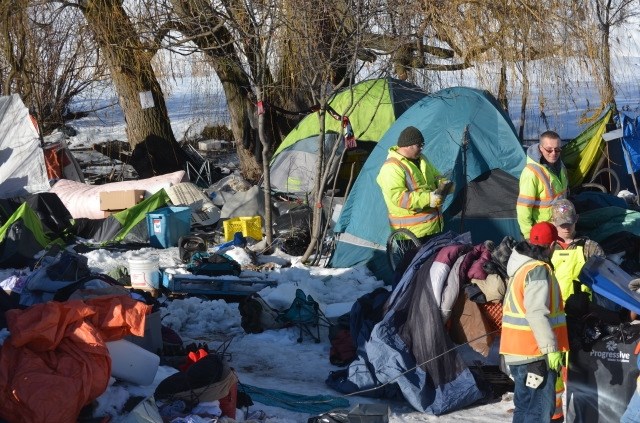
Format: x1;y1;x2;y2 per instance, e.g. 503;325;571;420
106;339;160;386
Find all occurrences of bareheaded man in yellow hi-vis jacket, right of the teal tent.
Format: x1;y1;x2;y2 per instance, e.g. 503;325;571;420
516;131;569;239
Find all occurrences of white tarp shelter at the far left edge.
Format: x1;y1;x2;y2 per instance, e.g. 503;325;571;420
0;94;49;198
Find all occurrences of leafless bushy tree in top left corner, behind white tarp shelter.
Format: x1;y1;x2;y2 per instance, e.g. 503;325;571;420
0;0;105;135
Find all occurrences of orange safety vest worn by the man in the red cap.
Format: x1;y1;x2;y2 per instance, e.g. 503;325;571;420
500;260;569;357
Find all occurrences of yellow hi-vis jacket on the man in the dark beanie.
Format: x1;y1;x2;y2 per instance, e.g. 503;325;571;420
376;146;443;238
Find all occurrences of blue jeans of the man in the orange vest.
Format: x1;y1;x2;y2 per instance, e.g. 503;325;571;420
509;364;557;423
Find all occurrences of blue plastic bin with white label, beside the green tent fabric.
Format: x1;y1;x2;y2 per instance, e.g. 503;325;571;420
147;207;191;248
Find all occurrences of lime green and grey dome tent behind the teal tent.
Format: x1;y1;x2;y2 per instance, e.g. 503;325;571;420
270;78;426;196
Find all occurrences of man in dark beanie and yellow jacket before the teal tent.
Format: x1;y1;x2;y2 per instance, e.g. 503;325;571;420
376;126;450;242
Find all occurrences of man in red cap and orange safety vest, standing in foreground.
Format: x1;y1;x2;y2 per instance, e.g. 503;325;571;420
500;222;569;423
